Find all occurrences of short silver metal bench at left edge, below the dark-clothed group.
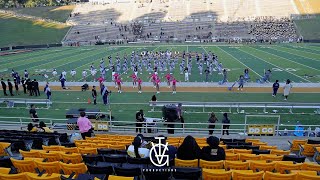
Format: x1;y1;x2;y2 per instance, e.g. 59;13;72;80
0;98;52;108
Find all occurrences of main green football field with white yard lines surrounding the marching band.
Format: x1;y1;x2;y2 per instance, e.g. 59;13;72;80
0;44;320;83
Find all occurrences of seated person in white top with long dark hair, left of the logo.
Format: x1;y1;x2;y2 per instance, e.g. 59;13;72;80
127;136;150;158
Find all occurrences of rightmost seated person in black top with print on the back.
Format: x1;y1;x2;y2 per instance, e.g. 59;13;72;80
201;136;226;161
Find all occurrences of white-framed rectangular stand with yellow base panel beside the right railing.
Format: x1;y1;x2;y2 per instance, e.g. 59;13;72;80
244;115;281;135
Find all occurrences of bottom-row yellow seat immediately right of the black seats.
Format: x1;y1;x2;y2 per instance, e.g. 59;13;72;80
202;169;232;180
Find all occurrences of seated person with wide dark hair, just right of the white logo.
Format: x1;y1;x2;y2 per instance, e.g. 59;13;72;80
177;135;201;160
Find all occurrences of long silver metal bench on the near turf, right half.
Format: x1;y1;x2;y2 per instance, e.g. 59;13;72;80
149;101;320;114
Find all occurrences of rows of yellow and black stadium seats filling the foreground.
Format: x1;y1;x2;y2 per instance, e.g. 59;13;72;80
0;131;320;180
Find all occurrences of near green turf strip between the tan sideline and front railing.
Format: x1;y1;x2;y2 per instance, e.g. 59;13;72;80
0;91;320;129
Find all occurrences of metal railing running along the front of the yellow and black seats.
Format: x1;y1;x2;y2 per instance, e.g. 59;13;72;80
0;116;319;136
